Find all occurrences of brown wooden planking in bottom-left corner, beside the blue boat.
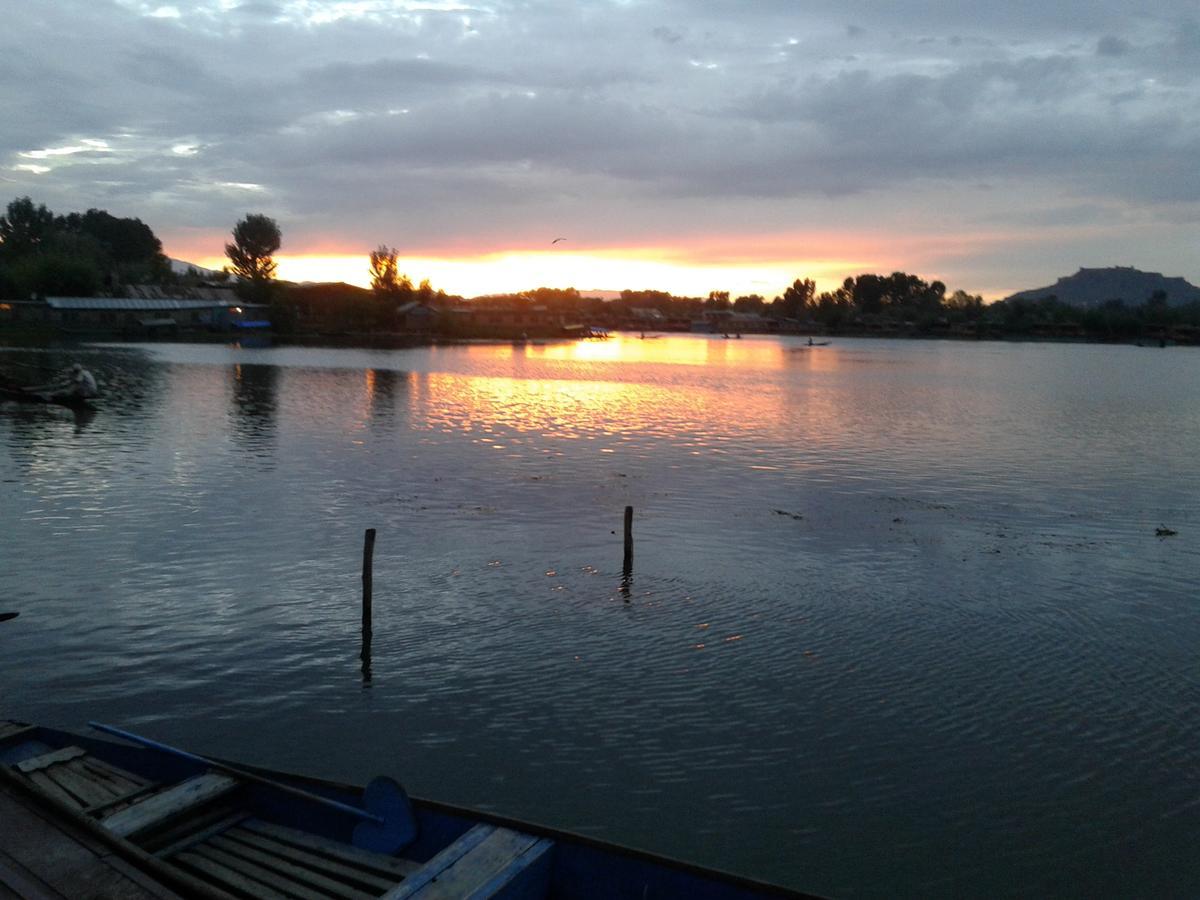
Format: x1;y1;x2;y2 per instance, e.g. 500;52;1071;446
0;778;180;900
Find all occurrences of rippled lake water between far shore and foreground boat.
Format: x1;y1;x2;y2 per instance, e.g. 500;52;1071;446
0;336;1200;896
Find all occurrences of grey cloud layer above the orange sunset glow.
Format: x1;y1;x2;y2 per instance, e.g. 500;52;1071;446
0;0;1200;259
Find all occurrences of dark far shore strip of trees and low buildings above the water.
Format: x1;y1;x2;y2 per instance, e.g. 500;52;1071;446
0;197;1200;347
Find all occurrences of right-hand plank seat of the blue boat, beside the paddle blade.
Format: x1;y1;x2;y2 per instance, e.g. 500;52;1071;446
380;824;554;900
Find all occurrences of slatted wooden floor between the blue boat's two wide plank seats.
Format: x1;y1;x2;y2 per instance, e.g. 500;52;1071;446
156;816;421;900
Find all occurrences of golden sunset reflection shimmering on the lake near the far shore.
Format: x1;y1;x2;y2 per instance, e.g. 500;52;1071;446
255;332;864;453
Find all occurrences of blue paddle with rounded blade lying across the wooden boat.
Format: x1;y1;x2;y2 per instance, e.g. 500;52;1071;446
88;722;416;853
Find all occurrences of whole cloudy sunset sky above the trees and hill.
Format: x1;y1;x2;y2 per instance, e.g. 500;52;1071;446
0;0;1200;299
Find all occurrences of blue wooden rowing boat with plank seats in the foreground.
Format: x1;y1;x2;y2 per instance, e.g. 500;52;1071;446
0;721;809;900
